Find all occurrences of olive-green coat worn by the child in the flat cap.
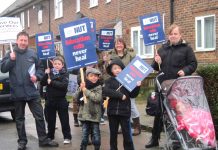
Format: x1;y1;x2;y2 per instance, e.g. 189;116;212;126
75;85;102;122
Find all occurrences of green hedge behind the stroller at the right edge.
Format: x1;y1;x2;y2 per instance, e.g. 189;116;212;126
197;64;218;138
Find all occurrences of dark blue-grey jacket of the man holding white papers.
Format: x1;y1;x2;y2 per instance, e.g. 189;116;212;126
1;47;44;101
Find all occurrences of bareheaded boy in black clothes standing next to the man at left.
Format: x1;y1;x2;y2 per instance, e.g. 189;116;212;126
41;56;71;144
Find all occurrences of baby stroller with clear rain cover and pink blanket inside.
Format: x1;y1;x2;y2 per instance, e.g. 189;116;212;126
156;73;217;150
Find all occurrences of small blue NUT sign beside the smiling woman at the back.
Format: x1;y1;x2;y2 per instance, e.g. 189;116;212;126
99;29;115;50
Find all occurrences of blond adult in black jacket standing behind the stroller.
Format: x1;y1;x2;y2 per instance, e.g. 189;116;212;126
145;24;197;148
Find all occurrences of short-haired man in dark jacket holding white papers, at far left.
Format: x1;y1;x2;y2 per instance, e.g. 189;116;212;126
1;32;58;150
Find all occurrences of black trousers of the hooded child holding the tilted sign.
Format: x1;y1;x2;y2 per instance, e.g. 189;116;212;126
108;115;134;150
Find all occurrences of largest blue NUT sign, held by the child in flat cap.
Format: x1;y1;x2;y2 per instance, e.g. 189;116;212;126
59;18;98;70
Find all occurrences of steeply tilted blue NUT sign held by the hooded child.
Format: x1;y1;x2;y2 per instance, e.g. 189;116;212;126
116;56;153;92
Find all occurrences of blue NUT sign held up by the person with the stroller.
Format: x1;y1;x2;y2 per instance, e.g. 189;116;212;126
139;13;165;45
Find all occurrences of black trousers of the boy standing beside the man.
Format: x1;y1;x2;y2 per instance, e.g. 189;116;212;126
46;99;71;139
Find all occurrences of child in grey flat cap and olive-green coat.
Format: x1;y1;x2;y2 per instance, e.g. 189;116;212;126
75;68;102;150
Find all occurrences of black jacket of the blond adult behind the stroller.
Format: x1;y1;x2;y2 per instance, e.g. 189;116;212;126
152;40;197;82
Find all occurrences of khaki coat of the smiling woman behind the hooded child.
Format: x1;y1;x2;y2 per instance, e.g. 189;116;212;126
109;48;136;66
